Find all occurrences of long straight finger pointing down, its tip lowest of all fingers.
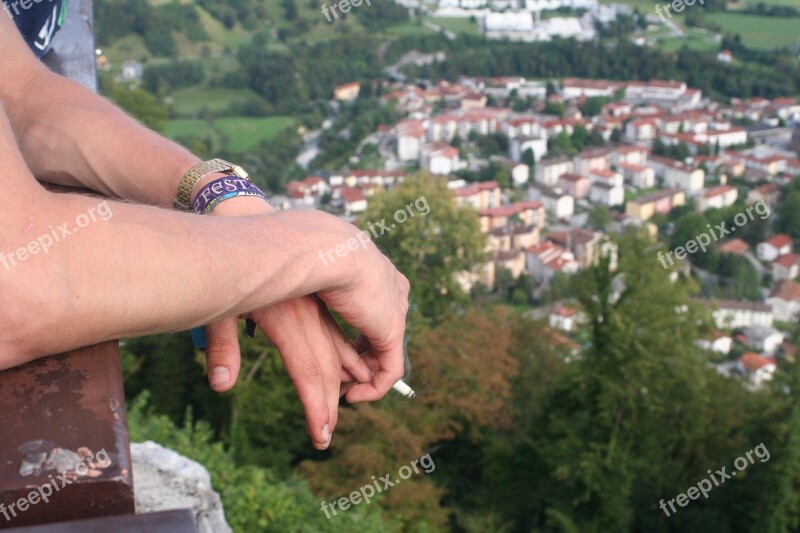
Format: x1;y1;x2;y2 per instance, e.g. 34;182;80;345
268;324;332;450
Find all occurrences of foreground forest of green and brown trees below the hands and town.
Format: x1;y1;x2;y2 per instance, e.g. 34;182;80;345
124;176;800;532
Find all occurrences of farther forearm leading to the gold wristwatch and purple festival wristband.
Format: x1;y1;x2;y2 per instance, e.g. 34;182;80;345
6;68;199;207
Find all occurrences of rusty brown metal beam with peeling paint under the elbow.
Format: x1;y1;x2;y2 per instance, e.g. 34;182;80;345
0;342;134;529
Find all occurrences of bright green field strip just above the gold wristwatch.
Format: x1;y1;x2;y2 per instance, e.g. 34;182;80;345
165;116;294;153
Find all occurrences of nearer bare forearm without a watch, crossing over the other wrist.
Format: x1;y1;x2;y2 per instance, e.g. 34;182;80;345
0;104;348;368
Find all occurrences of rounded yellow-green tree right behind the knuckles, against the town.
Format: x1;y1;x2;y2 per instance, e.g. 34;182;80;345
360;174;485;318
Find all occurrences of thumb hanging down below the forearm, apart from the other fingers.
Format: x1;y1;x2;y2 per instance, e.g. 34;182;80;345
206;318;242;392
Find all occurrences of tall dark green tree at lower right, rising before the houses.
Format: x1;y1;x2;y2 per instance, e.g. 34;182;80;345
493;237;746;532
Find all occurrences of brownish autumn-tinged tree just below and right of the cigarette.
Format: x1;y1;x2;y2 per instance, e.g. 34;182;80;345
300;307;517;531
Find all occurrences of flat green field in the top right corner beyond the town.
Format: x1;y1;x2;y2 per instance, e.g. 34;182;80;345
705;13;800;48
